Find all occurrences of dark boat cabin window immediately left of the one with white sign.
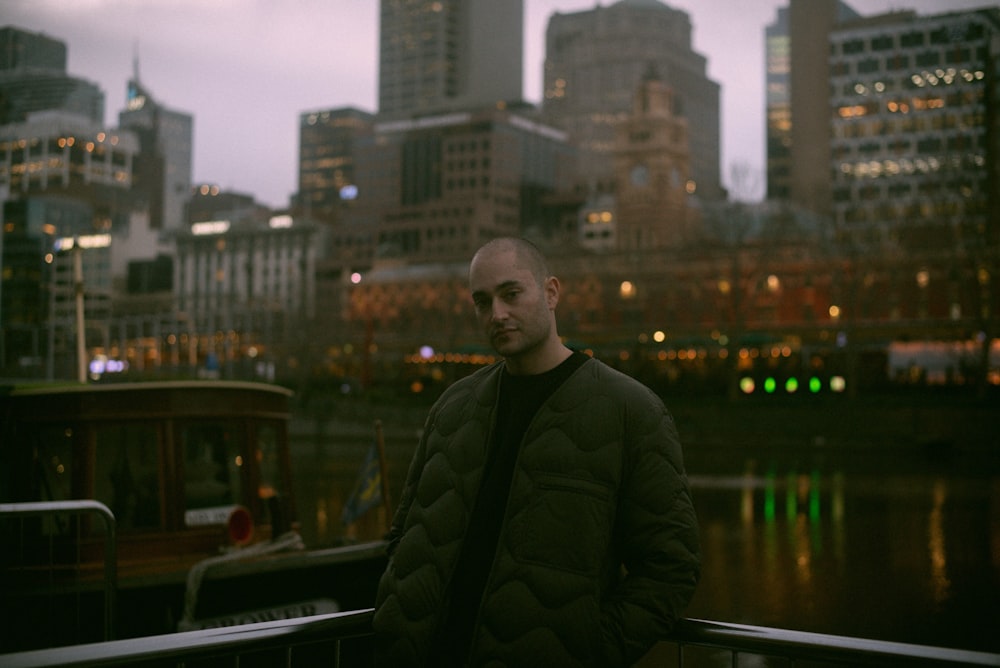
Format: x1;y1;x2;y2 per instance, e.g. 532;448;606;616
94;422;160;530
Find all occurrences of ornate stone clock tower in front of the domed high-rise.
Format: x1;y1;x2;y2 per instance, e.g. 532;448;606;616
613;68;695;250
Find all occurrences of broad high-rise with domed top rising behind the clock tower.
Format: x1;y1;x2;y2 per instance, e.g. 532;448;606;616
542;0;722;199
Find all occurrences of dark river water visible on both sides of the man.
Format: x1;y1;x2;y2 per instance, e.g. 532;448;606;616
293;418;1000;652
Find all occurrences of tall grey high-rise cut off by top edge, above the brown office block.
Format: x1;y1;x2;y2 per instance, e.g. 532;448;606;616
378;0;524;118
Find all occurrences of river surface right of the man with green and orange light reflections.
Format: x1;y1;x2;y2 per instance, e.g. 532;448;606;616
690;458;1000;651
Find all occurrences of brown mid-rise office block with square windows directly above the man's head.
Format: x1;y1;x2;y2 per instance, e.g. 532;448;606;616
366;109;575;262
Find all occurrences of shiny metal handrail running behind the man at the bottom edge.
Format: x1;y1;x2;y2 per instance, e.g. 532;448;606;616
0;609;1000;668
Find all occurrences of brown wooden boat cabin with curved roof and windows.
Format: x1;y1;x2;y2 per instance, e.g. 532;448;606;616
0;381;295;585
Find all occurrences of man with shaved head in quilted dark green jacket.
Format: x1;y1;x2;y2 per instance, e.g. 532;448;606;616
374;238;699;668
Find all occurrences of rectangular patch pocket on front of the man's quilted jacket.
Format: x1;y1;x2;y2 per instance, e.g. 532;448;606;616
509;474;614;575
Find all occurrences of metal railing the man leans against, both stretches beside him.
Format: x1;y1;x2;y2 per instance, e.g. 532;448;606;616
0;609;1000;668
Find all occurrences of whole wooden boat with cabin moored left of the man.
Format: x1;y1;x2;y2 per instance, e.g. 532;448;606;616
0;380;385;652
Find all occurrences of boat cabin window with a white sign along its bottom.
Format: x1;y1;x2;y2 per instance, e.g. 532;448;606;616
180;420;244;526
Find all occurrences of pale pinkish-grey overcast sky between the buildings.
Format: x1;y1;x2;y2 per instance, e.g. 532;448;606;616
0;0;996;207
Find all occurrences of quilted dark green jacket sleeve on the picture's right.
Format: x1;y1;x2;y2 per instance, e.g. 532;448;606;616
602;397;700;666
